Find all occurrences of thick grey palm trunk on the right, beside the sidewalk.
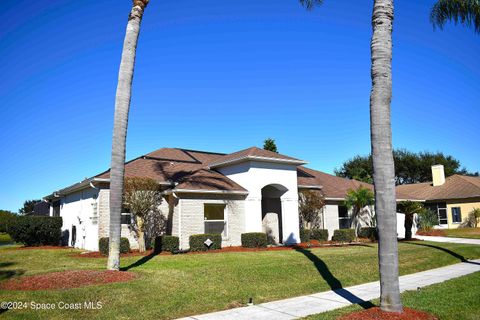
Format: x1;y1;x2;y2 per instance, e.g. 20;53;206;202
370;0;402;312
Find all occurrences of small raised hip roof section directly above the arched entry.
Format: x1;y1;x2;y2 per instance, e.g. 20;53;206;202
209;147;305;168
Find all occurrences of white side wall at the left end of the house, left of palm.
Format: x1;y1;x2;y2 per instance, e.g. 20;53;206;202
60;188;99;250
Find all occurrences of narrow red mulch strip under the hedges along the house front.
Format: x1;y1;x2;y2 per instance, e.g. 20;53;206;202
72;240;365;258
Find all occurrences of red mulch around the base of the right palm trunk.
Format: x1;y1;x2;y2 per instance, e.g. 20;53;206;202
337;307;438;320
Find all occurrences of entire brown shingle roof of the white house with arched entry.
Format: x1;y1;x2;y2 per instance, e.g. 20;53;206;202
45;147;373;199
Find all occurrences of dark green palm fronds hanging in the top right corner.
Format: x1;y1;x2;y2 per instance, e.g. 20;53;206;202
430;0;480;33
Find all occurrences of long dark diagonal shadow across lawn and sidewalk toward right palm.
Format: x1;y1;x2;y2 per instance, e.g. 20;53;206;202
296;248;375;309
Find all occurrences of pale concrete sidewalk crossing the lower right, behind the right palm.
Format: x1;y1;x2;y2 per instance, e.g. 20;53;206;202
178;259;480;320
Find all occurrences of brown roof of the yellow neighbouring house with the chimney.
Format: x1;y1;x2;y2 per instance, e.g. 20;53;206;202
397;174;480;201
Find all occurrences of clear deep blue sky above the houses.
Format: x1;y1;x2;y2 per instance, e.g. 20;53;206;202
0;0;480;211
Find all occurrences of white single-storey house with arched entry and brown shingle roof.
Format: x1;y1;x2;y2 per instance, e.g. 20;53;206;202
44;147;372;250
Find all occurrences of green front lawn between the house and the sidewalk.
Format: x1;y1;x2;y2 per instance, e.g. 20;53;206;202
0;242;480;319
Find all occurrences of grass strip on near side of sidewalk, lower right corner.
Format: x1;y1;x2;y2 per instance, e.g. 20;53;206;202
305;272;480;320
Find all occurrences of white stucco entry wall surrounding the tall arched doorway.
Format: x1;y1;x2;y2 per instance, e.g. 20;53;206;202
218;161;300;243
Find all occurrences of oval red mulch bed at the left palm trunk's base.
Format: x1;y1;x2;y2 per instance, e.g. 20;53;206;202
0;270;136;291
